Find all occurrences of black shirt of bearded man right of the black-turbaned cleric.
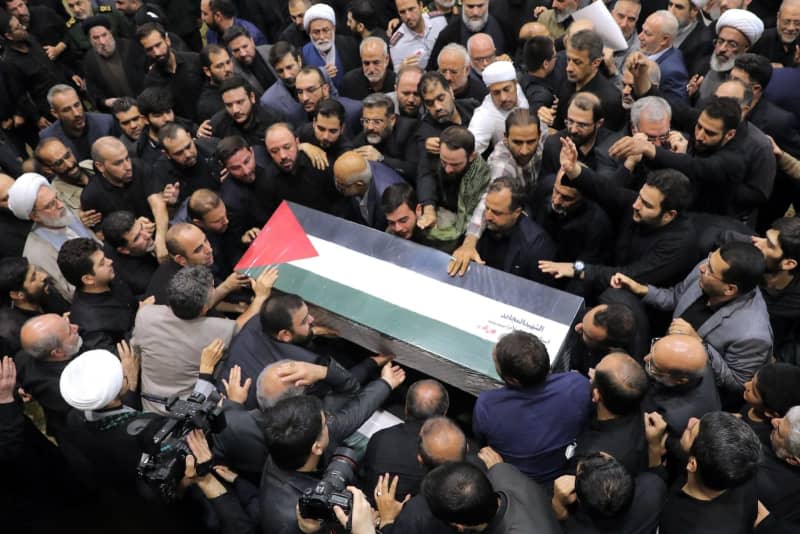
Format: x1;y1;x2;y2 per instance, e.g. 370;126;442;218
144;50;203;121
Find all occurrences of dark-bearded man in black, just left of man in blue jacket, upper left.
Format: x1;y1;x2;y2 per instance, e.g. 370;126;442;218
211;75;279;146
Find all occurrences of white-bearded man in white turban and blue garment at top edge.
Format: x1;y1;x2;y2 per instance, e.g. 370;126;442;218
303;4;360;89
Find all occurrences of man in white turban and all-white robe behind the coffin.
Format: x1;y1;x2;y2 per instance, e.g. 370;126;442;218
469;61;528;154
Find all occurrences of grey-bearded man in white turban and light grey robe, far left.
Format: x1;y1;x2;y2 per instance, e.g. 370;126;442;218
8;176;97;301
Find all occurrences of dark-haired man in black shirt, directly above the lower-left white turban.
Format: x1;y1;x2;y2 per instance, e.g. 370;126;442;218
58;237;138;351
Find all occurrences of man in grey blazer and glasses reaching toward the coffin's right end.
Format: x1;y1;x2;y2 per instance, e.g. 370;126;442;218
611;242;772;406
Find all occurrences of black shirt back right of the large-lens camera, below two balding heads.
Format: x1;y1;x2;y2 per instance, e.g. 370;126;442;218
360;421;427;502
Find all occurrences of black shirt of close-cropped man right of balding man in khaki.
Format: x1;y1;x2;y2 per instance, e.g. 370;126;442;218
81;160;159;221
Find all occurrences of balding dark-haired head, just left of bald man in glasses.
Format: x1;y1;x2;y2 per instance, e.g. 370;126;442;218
592;352;648;416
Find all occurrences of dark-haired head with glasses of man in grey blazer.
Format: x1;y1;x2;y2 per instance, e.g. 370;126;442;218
700;242;766;302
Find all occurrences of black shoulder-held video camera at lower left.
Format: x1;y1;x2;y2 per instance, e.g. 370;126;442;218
136;391;225;502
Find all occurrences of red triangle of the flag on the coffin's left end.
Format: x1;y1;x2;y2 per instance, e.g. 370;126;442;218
234;200;319;271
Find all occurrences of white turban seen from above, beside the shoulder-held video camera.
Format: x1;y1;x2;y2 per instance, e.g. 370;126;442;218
59;349;122;411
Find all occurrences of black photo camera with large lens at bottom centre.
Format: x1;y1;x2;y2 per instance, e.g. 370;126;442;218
300;447;358;521
